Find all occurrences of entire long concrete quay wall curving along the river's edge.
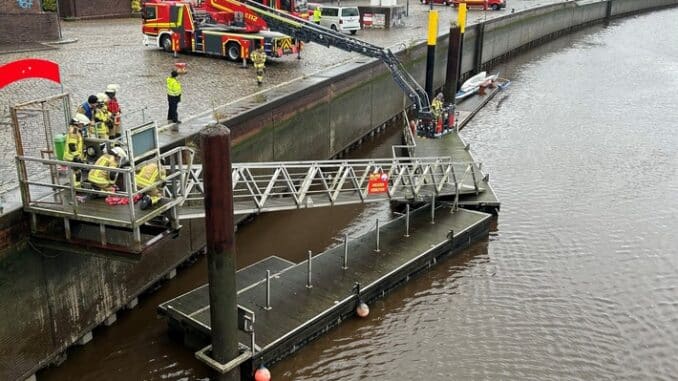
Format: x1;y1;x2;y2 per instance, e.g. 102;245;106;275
0;0;678;380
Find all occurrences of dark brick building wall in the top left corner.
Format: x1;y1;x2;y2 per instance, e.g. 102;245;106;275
0;0;59;43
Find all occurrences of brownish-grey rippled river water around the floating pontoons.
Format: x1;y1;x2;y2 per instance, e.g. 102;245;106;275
38;9;678;380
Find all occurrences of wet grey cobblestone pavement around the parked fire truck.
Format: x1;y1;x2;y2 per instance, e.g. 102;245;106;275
0;0;555;192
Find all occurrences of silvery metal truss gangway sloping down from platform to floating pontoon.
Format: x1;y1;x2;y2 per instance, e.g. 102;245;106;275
178;157;485;219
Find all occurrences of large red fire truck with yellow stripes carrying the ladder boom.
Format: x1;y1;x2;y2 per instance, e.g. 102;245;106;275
142;0;308;61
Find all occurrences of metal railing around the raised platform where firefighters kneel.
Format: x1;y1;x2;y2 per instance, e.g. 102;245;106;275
16;147;194;242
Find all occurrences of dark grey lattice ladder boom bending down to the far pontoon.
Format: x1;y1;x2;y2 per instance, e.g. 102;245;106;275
242;0;431;118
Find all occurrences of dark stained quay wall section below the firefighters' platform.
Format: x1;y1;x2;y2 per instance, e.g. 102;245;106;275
0;221;205;380
